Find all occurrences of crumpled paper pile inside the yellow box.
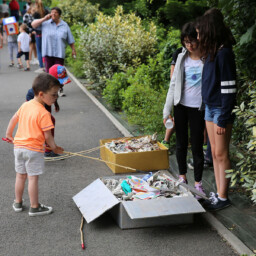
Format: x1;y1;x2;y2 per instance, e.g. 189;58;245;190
105;133;160;154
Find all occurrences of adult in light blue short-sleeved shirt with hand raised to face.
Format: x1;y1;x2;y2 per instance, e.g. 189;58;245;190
32;7;76;73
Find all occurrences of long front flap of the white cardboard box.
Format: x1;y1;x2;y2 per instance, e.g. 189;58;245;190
122;196;205;219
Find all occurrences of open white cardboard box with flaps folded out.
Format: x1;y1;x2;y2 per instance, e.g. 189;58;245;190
73;173;205;229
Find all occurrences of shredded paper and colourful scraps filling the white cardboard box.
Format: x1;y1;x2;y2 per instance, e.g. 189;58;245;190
102;171;188;201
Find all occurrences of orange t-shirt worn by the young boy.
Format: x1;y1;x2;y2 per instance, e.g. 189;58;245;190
13;99;54;152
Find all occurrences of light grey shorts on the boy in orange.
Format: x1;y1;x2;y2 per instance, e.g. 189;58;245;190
14;148;44;176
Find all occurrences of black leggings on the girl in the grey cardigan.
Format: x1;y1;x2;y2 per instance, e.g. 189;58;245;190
174;104;205;182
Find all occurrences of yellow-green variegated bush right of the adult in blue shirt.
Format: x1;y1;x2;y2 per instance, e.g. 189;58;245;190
80;6;156;82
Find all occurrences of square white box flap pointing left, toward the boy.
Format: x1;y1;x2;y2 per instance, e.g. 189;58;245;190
73;179;119;223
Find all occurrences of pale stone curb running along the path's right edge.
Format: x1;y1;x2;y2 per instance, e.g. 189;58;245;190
66;68;255;256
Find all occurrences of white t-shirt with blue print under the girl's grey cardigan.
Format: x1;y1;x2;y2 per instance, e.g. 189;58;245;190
180;56;203;108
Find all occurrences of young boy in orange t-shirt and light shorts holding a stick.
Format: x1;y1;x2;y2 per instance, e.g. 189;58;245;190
6;73;63;216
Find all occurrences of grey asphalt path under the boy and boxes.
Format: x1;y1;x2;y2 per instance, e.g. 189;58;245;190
0;46;237;256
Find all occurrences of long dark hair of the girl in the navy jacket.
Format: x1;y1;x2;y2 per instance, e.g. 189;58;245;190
196;8;235;60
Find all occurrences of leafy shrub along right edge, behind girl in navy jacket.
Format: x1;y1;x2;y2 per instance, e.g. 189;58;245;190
213;0;256;203
